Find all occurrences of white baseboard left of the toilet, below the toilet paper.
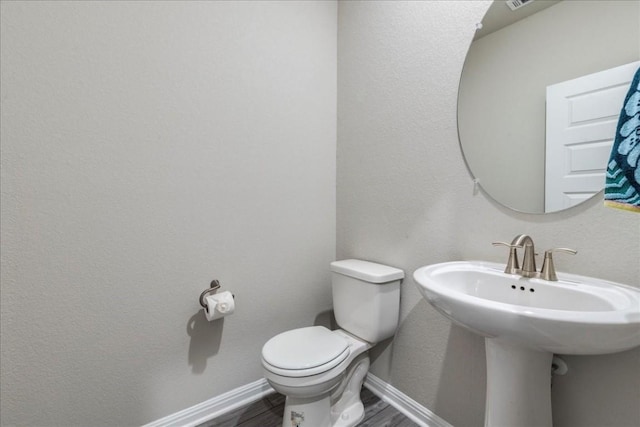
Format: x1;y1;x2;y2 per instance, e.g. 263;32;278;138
143;378;275;427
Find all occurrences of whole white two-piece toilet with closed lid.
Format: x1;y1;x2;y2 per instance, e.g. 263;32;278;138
262;259;404;427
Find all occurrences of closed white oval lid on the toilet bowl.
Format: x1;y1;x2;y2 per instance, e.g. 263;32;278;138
262;326;349;376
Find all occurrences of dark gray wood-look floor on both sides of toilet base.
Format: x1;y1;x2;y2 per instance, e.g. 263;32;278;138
198;387;418;427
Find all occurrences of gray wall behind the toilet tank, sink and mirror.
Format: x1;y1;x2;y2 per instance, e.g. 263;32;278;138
337;1;640;427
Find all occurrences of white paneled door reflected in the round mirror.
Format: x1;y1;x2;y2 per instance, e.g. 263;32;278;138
545;61;640;212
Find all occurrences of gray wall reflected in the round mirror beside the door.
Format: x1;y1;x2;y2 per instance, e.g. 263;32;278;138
458;0;640;212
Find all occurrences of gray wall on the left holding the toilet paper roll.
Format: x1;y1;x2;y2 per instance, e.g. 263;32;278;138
0;1;337;426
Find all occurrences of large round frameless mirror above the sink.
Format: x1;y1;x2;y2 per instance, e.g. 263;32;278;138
458;0;640;213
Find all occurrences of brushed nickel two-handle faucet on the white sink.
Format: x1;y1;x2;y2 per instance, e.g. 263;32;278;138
493;234;577;281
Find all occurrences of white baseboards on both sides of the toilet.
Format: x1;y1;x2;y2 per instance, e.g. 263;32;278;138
147;373;453;427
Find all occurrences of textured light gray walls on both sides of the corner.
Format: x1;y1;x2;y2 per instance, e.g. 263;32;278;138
0;1;640;427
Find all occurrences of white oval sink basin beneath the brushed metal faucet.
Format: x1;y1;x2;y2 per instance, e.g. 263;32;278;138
413;261;640;354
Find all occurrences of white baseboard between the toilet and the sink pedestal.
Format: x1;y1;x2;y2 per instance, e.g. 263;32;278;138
364;373;453;427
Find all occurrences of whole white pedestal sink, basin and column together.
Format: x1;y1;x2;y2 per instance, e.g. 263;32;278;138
413;261;640;427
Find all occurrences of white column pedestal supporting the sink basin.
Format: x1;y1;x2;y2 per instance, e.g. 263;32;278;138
484;338;553;427
